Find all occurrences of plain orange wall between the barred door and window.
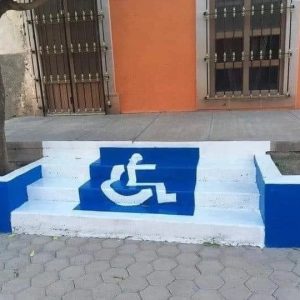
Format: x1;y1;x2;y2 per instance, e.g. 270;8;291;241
110;0;196;112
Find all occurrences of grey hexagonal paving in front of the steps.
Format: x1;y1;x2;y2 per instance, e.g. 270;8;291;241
0;235;300;300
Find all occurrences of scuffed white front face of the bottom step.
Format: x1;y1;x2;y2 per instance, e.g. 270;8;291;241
12;213;264;247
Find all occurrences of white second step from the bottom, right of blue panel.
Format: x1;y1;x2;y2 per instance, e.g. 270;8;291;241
195;181;259;210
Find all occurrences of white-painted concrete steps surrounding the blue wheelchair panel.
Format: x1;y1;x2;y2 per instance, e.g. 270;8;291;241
12;142;264;247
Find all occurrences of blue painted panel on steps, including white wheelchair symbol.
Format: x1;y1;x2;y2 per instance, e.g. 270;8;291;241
79;148;199;215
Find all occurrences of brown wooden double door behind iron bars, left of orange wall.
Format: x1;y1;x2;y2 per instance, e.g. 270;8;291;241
27;0;109;113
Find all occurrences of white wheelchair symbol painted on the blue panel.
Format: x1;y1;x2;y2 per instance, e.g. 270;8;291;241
101;153;176;206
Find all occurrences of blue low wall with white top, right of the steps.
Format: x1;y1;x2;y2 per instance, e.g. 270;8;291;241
255;155;300;248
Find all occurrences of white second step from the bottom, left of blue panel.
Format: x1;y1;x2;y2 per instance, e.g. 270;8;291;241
27;178;86;202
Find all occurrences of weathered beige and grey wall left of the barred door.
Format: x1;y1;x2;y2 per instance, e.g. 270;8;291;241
0;11;40;119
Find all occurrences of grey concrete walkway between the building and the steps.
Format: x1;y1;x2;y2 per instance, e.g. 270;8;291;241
6;110;300;142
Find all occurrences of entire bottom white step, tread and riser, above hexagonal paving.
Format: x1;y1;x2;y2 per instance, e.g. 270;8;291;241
12;201;264;247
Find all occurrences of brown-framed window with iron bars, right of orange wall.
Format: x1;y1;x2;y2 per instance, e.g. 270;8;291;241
207;0;290;98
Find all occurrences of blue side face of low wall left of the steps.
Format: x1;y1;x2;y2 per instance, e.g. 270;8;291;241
0;166;42;233
